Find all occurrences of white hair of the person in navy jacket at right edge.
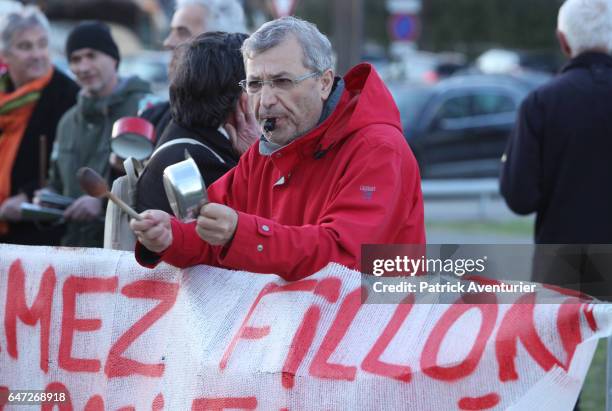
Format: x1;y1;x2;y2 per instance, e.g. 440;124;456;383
557;0;612;57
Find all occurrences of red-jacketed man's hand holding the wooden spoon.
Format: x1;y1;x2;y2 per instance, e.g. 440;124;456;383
130;210;172;254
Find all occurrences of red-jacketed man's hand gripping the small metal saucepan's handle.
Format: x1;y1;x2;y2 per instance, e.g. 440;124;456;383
196;203;238;245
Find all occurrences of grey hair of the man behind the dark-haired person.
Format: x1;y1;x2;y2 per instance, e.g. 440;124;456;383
176;0;247;33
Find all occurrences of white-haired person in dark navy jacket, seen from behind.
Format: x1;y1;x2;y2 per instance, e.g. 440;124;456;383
501;0;612;410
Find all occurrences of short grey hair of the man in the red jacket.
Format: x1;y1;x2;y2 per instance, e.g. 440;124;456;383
242;17;334;73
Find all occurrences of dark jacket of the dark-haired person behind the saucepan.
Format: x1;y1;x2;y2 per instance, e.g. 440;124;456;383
136;121;238;214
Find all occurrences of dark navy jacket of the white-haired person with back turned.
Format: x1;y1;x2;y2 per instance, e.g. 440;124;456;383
501;52;612;244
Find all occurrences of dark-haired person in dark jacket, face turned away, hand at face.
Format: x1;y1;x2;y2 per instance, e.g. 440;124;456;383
136;32;250;213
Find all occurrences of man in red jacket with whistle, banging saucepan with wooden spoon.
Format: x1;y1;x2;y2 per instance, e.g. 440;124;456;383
131;17;425;281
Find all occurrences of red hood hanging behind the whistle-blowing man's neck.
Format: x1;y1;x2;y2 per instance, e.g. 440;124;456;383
313;63;402;149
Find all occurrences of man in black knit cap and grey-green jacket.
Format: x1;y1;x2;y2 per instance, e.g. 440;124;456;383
39;21;151;247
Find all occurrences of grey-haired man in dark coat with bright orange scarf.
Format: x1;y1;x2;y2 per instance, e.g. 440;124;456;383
0;6;79;245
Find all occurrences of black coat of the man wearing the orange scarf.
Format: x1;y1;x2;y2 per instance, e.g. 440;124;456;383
0;68;79;245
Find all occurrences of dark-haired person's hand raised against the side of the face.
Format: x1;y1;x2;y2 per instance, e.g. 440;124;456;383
223;93;261;156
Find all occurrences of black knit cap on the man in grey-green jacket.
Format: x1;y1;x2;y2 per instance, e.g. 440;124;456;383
66;21;120;63
